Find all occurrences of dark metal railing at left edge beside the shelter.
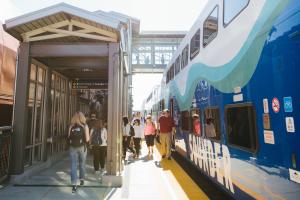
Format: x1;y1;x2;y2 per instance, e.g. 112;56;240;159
0;126;13;184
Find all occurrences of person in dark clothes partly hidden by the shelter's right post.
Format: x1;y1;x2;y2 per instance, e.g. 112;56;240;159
122;117;135;159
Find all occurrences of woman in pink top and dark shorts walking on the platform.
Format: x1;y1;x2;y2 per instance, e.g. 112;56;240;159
144;115;156;157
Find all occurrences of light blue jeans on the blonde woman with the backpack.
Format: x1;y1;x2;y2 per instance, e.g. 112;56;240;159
69;146;87;185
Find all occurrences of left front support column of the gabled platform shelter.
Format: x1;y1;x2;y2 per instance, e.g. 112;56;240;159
11;43;30;174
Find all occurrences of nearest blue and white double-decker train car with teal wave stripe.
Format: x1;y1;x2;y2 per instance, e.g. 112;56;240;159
158;0;300;199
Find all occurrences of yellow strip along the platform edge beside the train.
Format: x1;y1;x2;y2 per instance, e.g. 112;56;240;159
156;144;209;200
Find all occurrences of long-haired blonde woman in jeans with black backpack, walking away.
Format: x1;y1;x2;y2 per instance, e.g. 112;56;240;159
68;112;90;193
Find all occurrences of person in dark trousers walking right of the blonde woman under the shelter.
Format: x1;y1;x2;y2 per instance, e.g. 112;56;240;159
90;120;107;175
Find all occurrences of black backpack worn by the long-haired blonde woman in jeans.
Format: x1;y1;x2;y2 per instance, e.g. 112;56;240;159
69;124;86;147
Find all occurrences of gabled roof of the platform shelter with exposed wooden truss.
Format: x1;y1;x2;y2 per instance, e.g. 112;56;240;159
4;3;137;42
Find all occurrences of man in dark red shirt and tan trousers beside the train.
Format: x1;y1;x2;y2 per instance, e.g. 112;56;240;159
158;109;175;160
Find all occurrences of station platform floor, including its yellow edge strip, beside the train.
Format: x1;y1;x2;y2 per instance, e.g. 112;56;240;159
0;144;209;200
